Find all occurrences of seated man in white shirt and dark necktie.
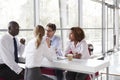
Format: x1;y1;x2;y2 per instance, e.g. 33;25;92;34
0;21;25;80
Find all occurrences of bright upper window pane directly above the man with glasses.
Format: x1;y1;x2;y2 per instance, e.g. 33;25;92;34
39;0;60;28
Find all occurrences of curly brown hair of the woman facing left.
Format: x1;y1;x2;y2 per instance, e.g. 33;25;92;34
70;27;85;42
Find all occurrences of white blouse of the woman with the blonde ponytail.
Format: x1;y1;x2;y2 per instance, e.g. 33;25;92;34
24;39;56;68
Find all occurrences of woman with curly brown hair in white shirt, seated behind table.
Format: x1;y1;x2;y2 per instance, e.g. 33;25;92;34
65;27;90;80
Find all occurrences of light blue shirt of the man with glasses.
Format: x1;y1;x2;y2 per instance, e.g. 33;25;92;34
44;35;63;56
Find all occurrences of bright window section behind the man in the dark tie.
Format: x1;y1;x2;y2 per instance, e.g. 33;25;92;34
0;0;34;40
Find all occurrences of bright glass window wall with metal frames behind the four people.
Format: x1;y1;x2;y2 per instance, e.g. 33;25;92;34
0;0;120;54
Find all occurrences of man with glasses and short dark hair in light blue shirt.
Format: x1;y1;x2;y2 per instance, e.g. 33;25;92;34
41;23;63;80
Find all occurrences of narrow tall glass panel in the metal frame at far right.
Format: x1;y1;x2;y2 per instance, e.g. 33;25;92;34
105;7;114;50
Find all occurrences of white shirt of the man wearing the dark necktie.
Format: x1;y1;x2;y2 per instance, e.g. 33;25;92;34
0;33;24;74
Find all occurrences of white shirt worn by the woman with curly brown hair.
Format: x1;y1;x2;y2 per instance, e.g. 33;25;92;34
65;39;90;59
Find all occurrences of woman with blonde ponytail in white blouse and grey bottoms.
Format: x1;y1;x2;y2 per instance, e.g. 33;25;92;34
24;25;56;80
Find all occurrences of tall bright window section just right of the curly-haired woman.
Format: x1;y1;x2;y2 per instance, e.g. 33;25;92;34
83;0;102;53
